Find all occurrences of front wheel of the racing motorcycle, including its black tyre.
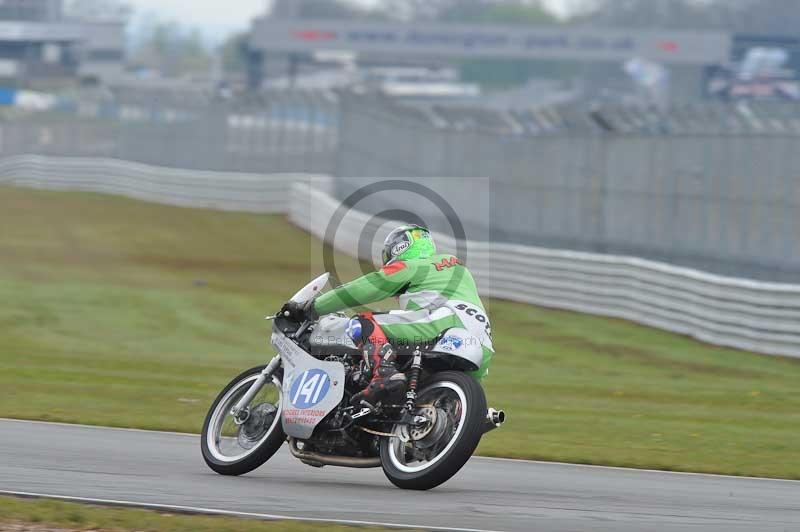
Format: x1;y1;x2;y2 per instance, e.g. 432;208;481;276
201;366;286;475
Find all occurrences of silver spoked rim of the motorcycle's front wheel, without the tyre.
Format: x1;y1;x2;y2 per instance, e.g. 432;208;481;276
206;373;282;463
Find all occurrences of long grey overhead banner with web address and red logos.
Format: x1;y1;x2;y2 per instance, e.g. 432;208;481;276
250;17;731;65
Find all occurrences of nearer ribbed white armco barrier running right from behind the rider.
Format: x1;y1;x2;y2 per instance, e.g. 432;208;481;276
289;181;800;357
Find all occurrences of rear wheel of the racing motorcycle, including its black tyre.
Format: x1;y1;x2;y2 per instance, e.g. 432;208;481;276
381;371;486;490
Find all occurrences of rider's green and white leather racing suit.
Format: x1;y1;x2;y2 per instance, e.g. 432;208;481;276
314;254;494;379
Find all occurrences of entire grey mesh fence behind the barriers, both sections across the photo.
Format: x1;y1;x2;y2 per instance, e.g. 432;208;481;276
0;89;800;282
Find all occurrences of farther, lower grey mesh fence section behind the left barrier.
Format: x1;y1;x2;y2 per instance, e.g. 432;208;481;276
0;91;338;173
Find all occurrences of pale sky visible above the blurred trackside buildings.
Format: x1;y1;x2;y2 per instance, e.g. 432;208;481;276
126;0;571;42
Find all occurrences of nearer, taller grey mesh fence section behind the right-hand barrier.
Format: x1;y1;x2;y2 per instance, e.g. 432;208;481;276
337;94;800;282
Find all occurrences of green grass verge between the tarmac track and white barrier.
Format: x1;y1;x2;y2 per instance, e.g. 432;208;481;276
0;188;800;478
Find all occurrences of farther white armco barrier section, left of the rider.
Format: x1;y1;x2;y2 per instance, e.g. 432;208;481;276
0;155;328;213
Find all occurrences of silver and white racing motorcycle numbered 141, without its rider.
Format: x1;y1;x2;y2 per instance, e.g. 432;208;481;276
201;273;505;490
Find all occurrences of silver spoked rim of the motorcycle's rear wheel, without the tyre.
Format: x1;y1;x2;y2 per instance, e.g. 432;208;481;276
388;381;469;473
